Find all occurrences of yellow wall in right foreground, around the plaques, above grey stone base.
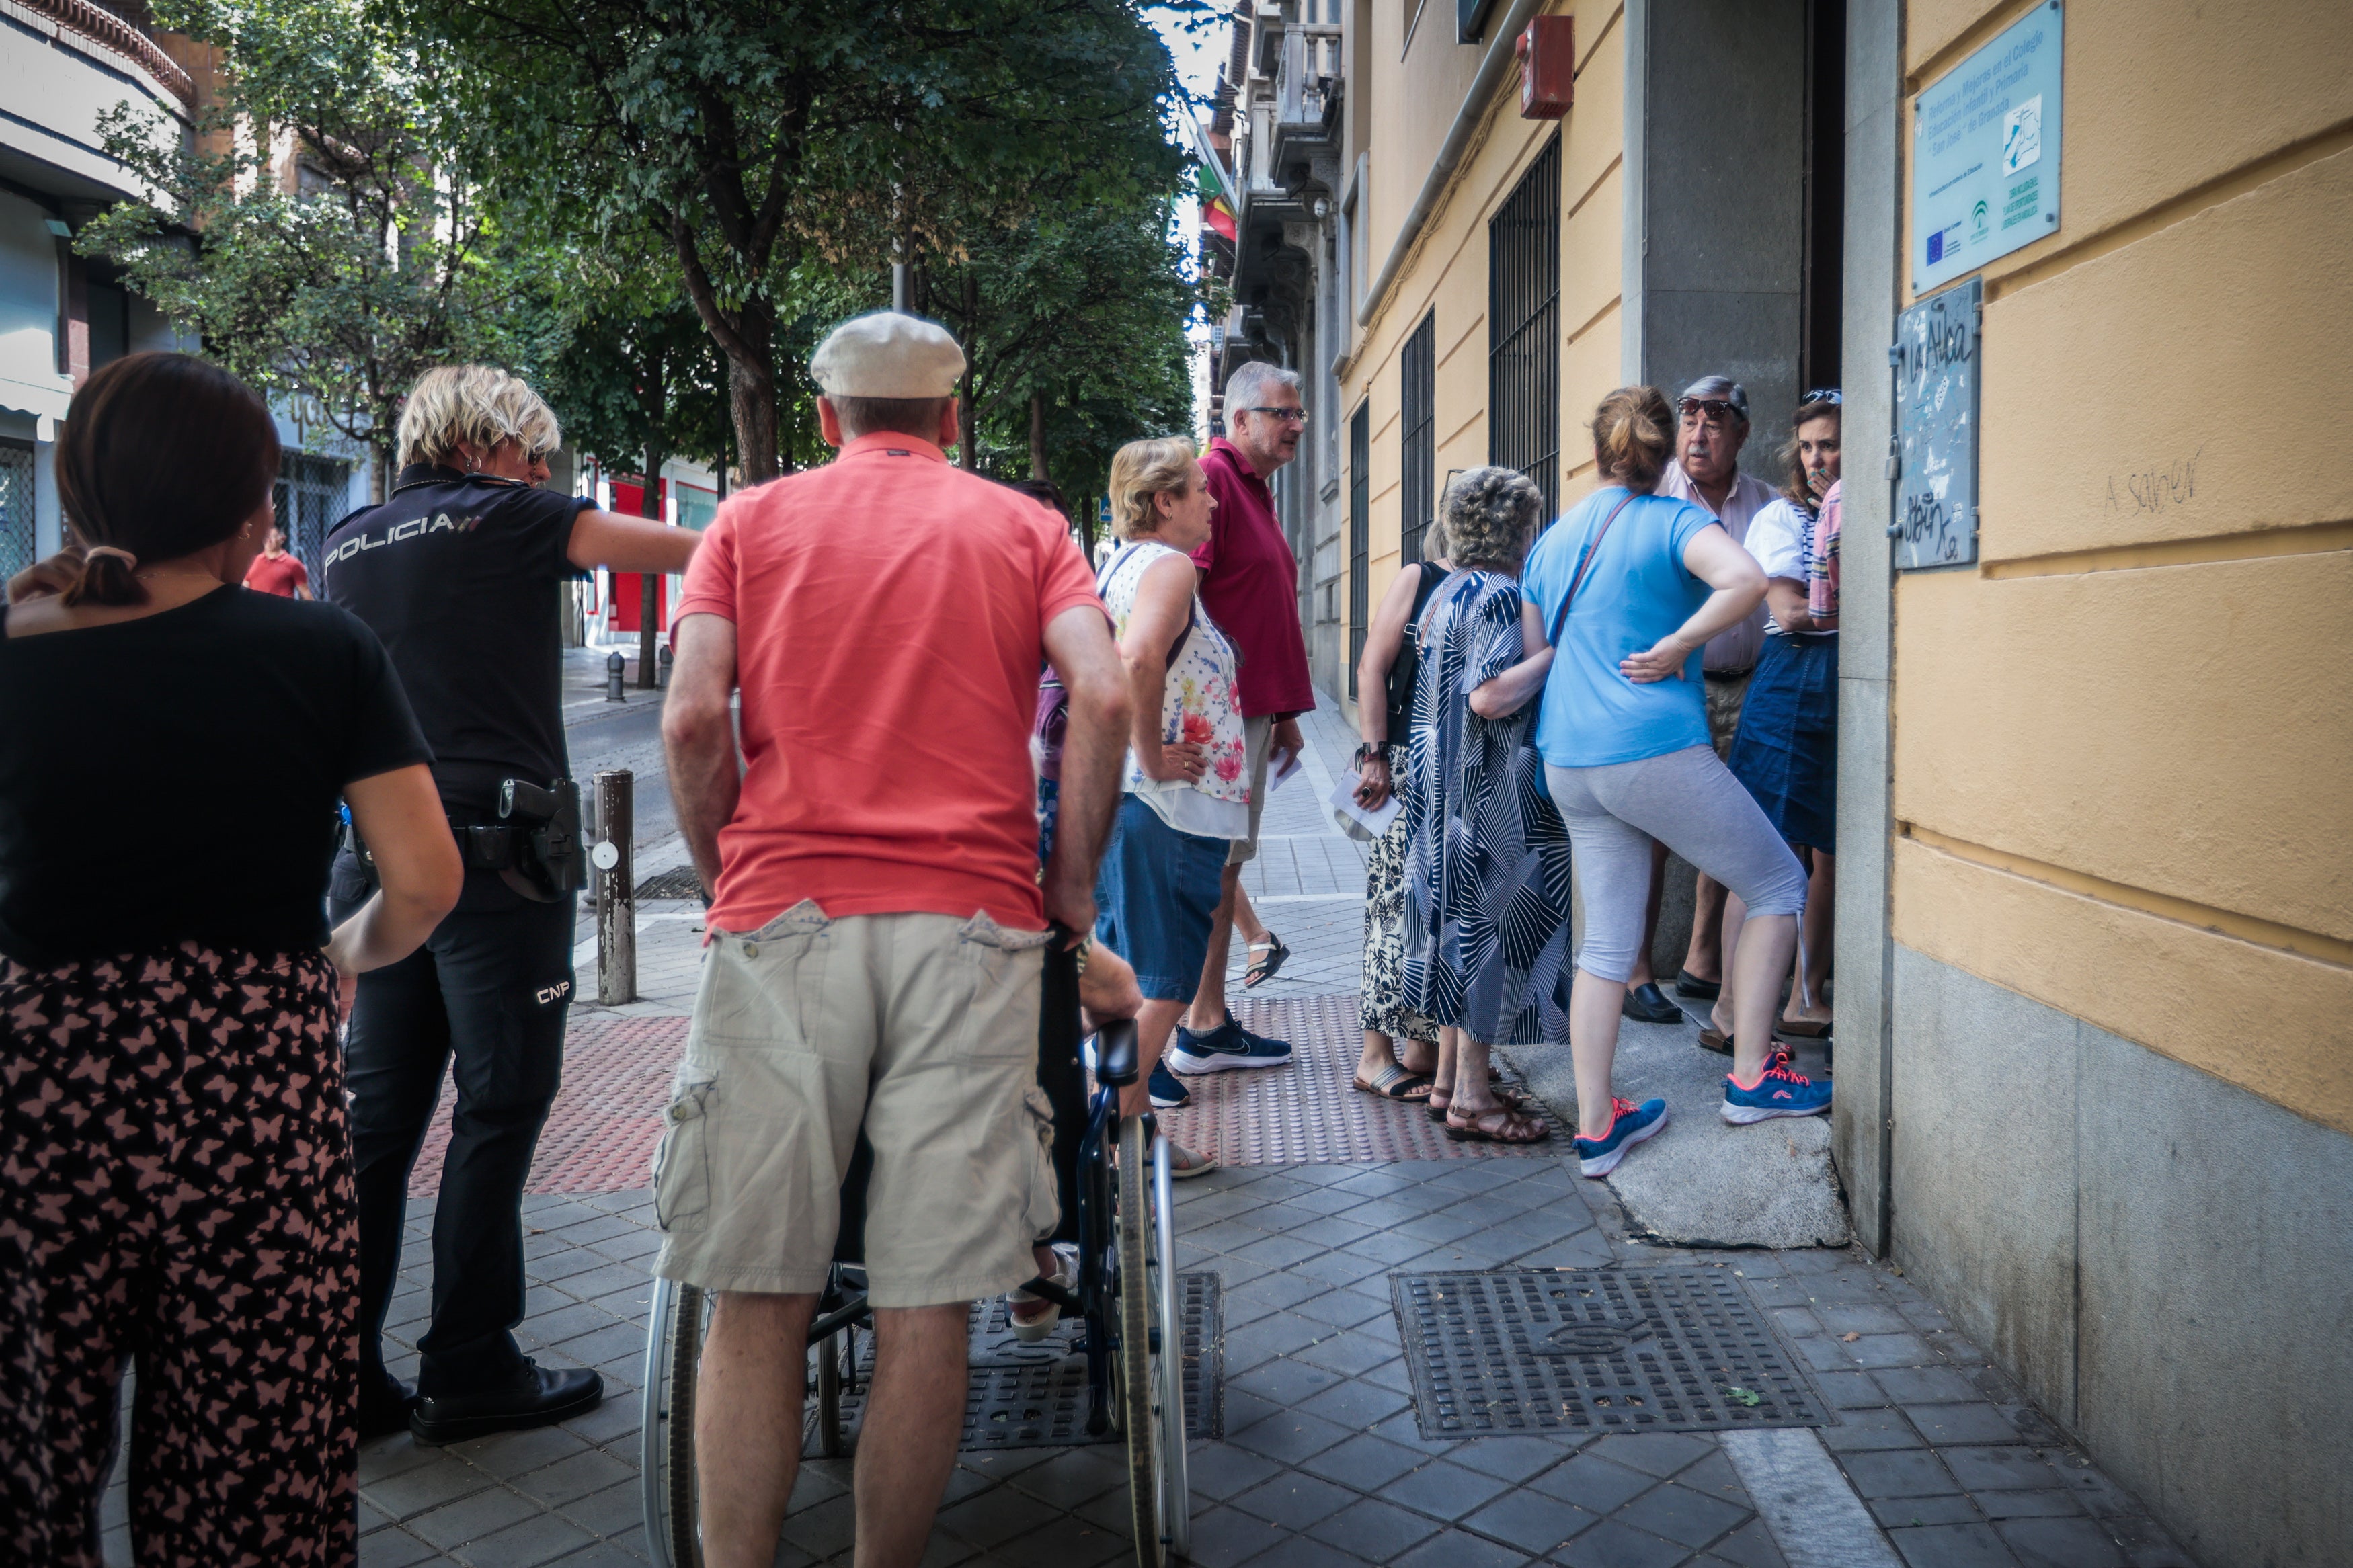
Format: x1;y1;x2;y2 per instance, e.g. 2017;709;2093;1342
1892;0;2353;1133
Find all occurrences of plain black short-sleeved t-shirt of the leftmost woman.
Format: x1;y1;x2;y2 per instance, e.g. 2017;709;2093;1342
0;587;431;968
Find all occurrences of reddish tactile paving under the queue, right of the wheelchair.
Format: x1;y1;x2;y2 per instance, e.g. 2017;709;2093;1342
1160;992;1570;1166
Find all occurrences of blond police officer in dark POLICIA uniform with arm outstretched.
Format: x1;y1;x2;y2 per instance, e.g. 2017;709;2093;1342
323;364;699;1444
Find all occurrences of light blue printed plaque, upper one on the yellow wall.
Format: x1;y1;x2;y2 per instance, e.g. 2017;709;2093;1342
1911;0;2066;294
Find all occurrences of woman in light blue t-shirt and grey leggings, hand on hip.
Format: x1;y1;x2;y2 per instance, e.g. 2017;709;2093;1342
1520;386;1831;1175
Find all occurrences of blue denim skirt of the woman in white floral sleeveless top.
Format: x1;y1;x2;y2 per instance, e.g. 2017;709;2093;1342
1094;794;1233;1001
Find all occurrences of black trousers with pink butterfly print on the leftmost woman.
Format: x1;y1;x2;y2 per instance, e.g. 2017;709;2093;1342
0;943;360;1568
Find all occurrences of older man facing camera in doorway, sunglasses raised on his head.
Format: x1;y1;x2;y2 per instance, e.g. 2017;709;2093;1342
1626;376;1774;1023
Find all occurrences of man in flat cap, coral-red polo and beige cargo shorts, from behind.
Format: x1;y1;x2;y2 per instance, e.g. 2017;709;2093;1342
654;311;1127;1568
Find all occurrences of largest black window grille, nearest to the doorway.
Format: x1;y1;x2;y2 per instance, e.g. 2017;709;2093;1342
1487;136;1560;526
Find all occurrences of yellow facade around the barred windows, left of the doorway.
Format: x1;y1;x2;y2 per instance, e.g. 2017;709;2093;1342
1339;0;1626;717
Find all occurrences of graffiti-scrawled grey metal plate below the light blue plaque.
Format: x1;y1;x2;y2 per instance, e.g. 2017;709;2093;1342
1887;278;1986;569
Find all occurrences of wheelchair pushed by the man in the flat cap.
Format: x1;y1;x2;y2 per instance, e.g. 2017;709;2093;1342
640;950;1191;1568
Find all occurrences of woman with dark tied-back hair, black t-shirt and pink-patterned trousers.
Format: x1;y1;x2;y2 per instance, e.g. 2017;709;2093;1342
0;355;464;1566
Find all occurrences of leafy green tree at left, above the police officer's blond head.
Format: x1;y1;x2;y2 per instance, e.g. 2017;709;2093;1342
75;0;555;499
